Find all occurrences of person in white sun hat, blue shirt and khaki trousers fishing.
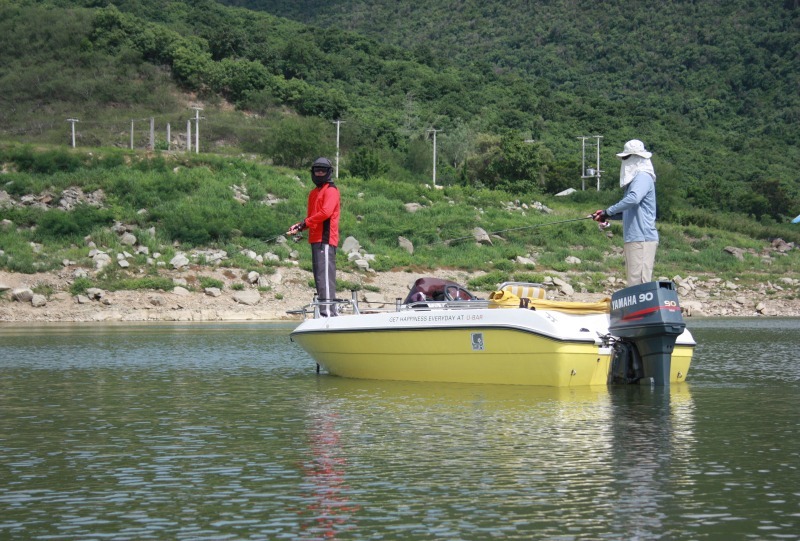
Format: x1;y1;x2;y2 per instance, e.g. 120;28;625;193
592;139;658;287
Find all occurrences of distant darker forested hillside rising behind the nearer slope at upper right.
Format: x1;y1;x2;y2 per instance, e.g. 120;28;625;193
219;0;800;217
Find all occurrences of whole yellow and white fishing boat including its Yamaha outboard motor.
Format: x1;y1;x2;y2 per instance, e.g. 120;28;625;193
291;278;695;387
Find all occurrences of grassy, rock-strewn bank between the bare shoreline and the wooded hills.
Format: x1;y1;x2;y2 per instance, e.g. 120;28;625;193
0;145;800;292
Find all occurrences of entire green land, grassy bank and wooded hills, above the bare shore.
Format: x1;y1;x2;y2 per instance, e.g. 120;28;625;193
0;0;800;296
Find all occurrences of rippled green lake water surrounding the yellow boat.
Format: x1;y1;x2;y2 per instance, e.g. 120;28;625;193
0;319;800;541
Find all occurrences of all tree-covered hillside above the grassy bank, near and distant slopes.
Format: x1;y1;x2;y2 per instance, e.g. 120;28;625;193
0;0;800;222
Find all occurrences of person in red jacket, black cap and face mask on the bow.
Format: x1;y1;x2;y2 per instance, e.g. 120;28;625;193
287;158;340;317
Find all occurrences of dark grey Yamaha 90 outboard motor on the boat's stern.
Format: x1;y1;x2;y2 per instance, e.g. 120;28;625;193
608;281;686;386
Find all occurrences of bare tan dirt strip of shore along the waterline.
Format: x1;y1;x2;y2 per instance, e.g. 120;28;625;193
0;267;800;323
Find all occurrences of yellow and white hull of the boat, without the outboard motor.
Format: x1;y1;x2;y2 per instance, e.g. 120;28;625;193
292;309;694;387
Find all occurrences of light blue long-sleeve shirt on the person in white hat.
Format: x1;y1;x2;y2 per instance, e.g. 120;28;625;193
606;171;658;242
